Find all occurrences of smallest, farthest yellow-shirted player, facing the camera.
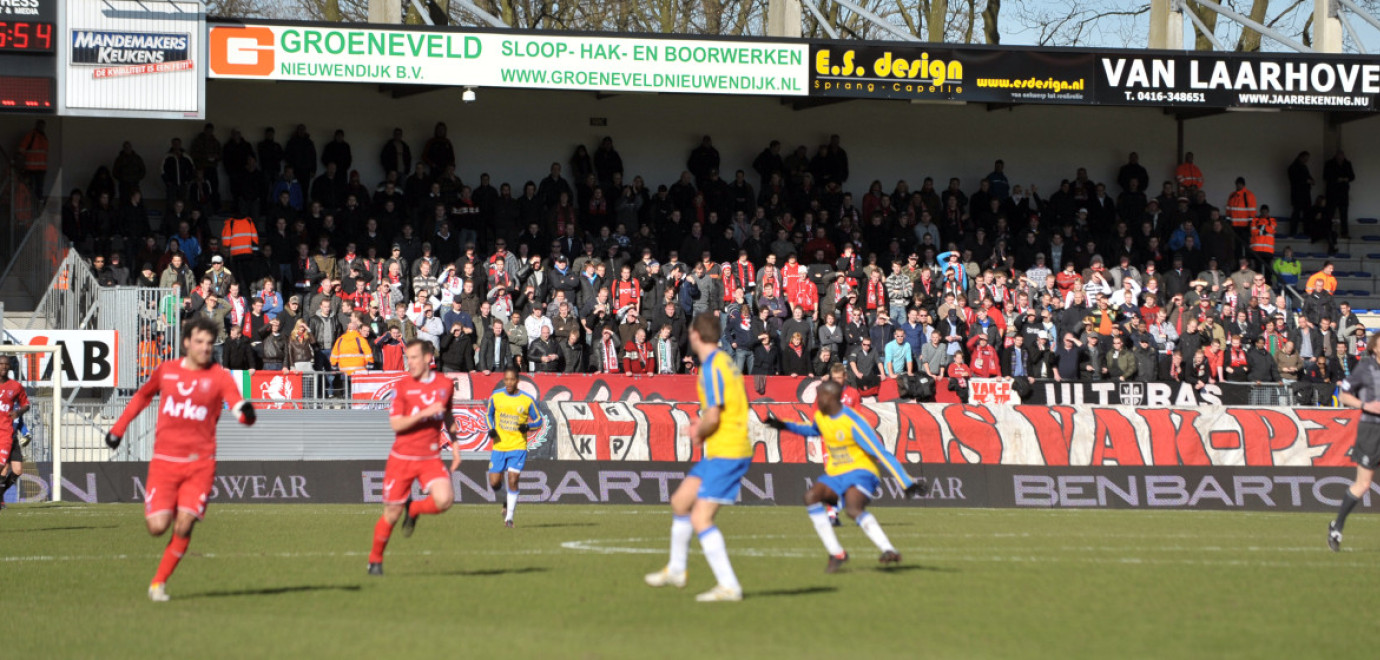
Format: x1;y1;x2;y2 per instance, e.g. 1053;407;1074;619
489;365;541;527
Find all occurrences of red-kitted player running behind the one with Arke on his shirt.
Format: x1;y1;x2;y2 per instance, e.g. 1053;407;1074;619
368;340;460;576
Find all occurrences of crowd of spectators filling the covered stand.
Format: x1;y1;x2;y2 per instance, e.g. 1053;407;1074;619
48;124;1365;398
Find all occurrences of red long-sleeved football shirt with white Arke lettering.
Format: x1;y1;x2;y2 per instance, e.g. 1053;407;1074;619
110;359;244;461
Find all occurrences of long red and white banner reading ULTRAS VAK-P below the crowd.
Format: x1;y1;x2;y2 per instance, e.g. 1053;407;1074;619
549;402;1358;467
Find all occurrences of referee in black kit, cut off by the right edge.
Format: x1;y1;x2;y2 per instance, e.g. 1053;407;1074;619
1328;333;1380;552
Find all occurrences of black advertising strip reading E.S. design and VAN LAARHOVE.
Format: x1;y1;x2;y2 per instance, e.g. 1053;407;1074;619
809;41;1380;112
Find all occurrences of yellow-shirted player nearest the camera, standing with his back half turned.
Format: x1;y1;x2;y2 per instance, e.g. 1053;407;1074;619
646;312;752;602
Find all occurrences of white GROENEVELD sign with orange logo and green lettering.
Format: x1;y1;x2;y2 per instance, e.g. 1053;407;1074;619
208;25;809;95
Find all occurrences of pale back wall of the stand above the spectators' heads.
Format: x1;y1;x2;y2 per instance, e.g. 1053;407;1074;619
18;81;1380;222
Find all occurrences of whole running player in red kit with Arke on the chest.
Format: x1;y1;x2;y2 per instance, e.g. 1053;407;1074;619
105;316;255;602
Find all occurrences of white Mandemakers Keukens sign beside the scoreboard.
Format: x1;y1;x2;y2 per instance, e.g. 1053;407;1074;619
58;0;206;119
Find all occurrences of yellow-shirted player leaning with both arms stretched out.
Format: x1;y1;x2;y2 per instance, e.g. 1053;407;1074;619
766;381;922;573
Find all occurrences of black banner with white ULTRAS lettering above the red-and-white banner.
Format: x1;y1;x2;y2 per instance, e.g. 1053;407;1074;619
1025;380;1256;407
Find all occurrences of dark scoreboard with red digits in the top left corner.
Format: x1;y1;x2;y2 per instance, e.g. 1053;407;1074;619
0;0;61;113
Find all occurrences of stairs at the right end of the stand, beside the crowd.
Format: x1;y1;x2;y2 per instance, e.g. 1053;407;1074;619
1275;218;1380;330
